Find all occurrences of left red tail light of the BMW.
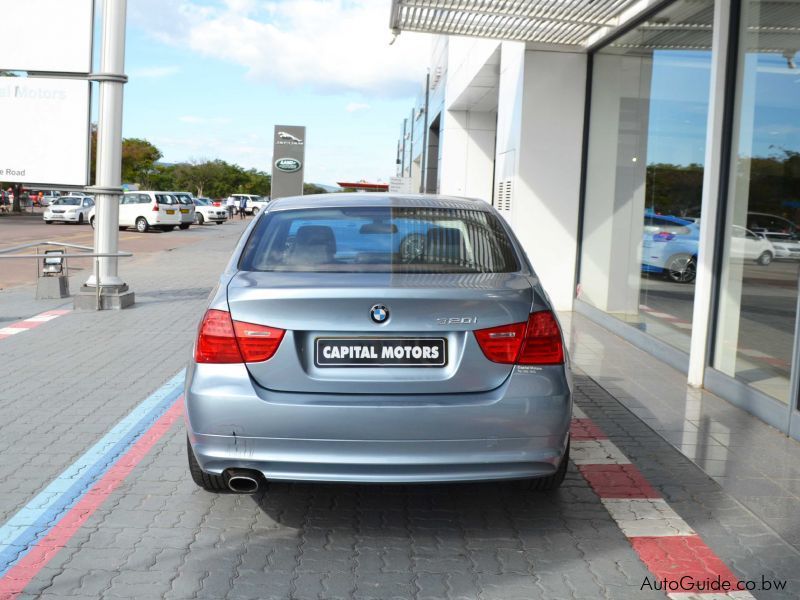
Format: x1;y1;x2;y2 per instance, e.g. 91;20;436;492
194;309;286;364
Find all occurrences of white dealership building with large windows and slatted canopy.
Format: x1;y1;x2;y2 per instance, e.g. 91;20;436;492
391;0;800;439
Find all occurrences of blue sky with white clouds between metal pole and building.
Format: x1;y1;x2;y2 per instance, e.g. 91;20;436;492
118;0;431;185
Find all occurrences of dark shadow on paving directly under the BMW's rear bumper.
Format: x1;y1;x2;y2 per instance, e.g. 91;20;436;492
252;472;616;548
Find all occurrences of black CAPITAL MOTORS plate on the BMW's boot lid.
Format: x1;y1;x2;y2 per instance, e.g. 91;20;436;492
314;338;447;367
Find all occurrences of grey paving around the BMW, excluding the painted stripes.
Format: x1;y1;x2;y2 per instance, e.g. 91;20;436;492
0;225;800;600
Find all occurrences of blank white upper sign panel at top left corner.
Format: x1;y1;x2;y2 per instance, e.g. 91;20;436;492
0;0;94;73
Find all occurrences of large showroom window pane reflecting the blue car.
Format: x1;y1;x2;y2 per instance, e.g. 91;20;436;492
578;0;714;352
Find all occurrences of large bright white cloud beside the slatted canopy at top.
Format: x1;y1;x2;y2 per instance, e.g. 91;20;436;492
130;0;430;96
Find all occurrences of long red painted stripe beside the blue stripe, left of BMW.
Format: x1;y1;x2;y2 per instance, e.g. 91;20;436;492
0;397;183;600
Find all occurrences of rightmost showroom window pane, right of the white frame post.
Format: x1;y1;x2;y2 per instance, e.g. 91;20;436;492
712;0;800;402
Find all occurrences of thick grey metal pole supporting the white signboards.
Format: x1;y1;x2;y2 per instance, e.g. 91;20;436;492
86;0;127;290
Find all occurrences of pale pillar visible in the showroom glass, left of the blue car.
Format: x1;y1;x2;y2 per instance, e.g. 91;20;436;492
579;54;652;320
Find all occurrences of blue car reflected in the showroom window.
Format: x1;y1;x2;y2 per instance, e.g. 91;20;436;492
642;212;700;283
